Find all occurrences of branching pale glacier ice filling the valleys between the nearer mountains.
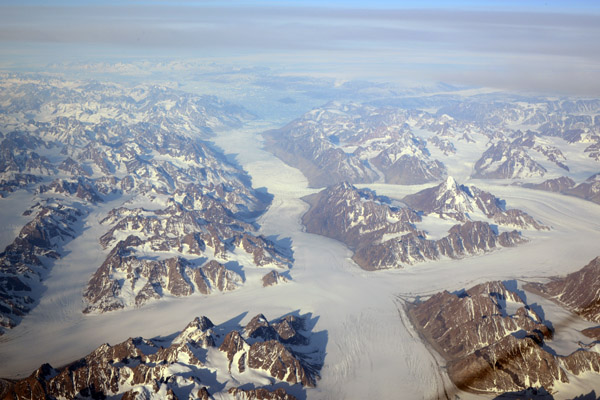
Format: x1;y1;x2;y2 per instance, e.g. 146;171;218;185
0;125;600;399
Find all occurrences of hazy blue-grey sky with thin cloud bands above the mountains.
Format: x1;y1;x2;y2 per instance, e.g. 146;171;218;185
0;0;600;95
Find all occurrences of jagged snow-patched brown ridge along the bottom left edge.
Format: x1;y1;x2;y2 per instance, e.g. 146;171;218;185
0;314;324;400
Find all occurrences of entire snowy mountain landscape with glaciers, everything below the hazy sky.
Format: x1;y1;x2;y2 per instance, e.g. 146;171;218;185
0;73;600;399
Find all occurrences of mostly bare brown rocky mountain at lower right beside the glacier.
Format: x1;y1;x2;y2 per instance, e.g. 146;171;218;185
408;282;600;393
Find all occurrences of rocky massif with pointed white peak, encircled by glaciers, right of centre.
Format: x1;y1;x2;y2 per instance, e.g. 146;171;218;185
302;177;548;270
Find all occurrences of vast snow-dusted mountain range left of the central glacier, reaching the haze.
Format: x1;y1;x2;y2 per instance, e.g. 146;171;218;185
0;75;292;334
